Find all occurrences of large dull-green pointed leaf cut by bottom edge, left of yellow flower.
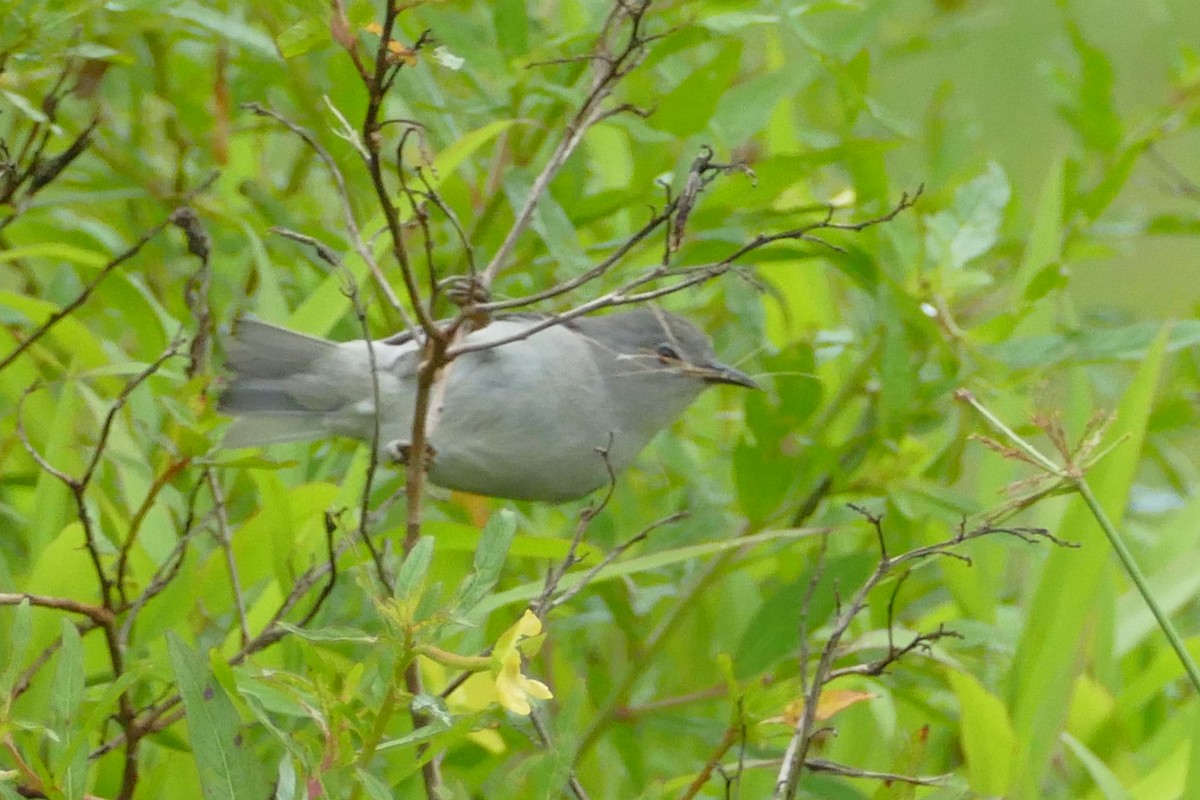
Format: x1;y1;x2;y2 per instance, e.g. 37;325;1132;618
167;633;270;800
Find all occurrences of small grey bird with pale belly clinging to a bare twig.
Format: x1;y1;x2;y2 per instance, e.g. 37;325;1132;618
221;308;756;503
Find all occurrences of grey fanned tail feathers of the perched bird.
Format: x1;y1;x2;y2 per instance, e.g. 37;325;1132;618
218;319;337;447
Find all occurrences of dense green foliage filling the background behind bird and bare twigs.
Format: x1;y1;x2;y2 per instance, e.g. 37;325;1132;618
0;0;1200;800
